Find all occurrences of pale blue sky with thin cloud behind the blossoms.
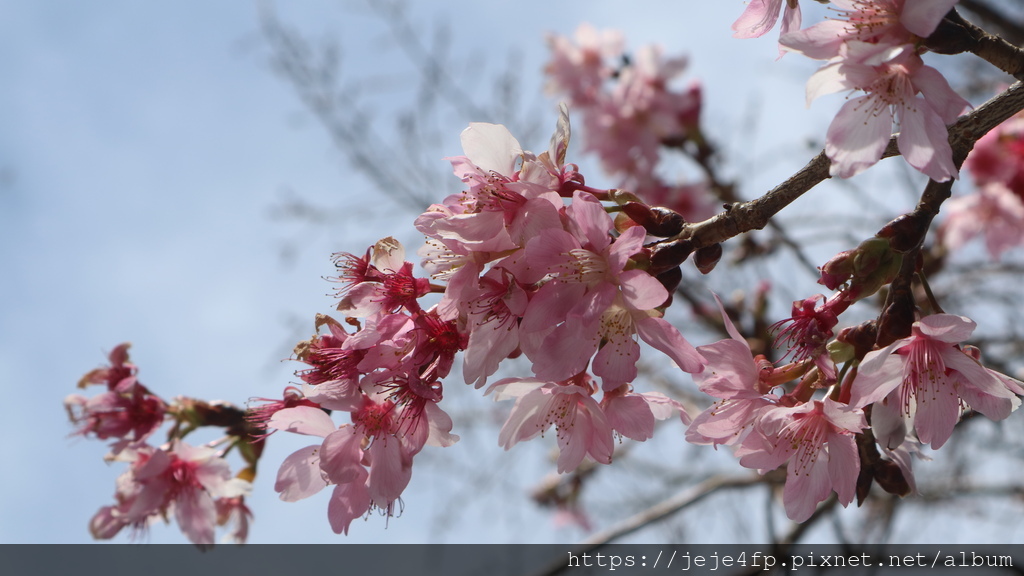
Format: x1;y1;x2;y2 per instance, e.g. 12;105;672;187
0;0;884;543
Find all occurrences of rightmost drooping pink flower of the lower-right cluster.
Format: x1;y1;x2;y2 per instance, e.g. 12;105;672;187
850;314;1021;449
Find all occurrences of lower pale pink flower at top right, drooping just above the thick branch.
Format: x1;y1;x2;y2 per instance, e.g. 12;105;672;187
807;41;970;181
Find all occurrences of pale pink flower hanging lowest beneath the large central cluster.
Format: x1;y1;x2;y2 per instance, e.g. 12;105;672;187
487;374;614;474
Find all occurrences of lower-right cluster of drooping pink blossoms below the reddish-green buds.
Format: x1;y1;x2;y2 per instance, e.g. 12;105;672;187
686;289;1024;522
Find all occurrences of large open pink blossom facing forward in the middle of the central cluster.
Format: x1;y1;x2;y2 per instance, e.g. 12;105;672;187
520;192;703;389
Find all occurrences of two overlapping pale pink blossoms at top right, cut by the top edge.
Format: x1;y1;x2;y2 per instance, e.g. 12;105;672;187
779;0;970;181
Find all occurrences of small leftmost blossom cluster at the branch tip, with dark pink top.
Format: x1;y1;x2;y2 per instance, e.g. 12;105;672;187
65;343;252;546
